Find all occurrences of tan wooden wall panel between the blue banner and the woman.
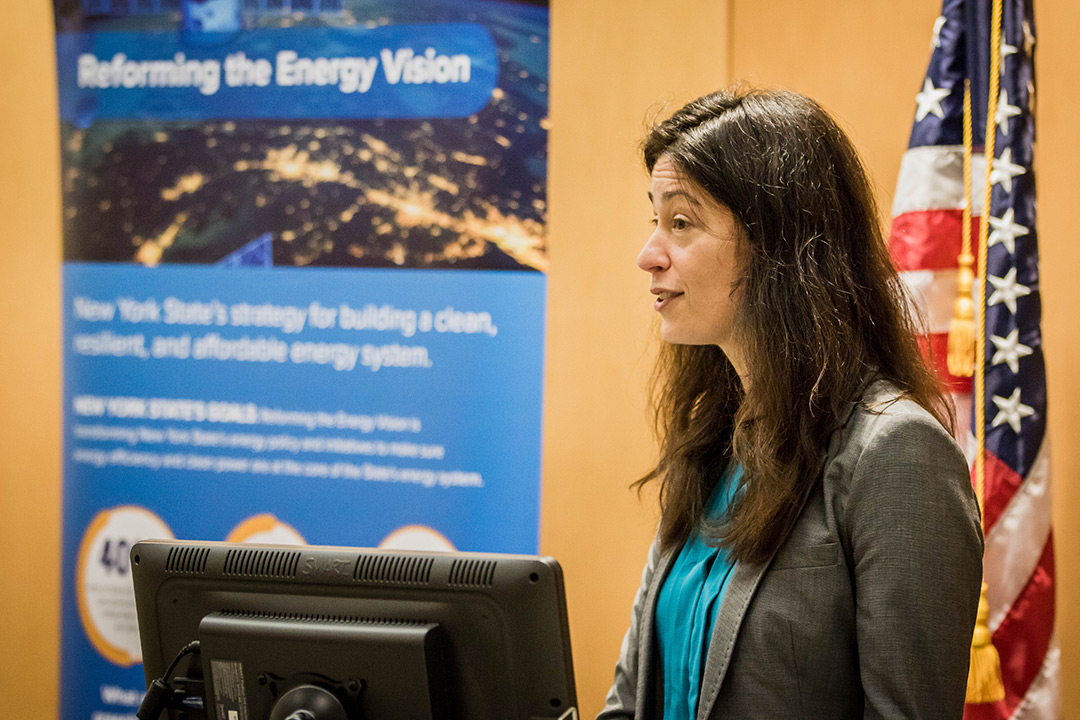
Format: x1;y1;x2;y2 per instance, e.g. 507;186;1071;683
541;0;728;718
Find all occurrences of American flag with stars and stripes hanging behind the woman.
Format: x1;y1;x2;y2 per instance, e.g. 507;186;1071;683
889;0;1061;720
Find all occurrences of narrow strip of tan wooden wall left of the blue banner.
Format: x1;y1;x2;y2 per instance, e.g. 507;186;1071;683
0;2;60;719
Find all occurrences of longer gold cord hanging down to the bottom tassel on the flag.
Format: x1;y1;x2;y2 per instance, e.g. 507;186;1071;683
967;0;1005;703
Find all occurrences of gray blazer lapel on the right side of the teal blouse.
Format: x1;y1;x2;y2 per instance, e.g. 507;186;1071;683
695;557;772;720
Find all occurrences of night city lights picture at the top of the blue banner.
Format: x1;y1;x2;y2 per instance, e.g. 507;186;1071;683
57;0;549;272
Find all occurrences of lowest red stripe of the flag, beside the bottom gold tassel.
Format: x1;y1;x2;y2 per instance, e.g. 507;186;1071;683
963;534;1054;720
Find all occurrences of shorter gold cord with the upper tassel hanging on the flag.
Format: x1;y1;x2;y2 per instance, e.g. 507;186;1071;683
945;79;975;378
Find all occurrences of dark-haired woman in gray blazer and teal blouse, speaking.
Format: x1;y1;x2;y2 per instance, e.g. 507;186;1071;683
599;91;983;720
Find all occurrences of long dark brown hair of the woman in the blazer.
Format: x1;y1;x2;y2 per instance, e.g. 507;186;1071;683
637;89;953;561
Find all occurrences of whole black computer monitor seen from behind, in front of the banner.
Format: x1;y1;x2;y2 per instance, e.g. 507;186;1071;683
131;540;577;720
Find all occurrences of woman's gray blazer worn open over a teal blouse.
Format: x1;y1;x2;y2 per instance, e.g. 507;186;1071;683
597;381;983;720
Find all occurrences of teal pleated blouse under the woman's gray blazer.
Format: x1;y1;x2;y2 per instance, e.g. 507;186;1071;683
657;465;743;720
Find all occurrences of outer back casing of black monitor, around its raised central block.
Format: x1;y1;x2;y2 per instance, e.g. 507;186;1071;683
131;540;577;720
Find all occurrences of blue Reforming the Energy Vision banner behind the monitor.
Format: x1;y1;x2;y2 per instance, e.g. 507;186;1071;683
54;0;549;720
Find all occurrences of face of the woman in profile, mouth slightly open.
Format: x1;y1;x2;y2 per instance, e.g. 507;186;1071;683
637;155;743;358
